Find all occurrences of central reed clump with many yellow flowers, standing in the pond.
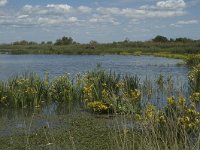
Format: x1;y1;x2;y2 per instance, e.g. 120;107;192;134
83;70;141;113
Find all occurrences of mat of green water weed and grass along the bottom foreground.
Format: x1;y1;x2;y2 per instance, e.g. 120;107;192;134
0;109;200;150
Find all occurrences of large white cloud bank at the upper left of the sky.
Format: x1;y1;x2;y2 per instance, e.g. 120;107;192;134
0;4;82;27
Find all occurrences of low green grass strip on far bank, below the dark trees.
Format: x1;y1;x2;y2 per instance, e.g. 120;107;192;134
0;41;200;57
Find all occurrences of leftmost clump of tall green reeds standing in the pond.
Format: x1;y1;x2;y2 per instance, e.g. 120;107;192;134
4;74;48;108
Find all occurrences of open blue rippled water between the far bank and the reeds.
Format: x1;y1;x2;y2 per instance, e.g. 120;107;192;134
0;55;188;81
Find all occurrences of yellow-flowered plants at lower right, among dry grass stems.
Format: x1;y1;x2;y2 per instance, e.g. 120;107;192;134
136;96;200;133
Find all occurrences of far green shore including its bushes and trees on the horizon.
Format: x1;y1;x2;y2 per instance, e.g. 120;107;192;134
0;36;200;58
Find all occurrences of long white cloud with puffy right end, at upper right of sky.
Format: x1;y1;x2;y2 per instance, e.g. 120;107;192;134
96;0;186;18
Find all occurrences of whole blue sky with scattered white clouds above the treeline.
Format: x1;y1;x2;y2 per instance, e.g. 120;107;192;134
0;0;200;43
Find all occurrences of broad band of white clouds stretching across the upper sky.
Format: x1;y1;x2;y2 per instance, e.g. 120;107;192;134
0;0;188;27
